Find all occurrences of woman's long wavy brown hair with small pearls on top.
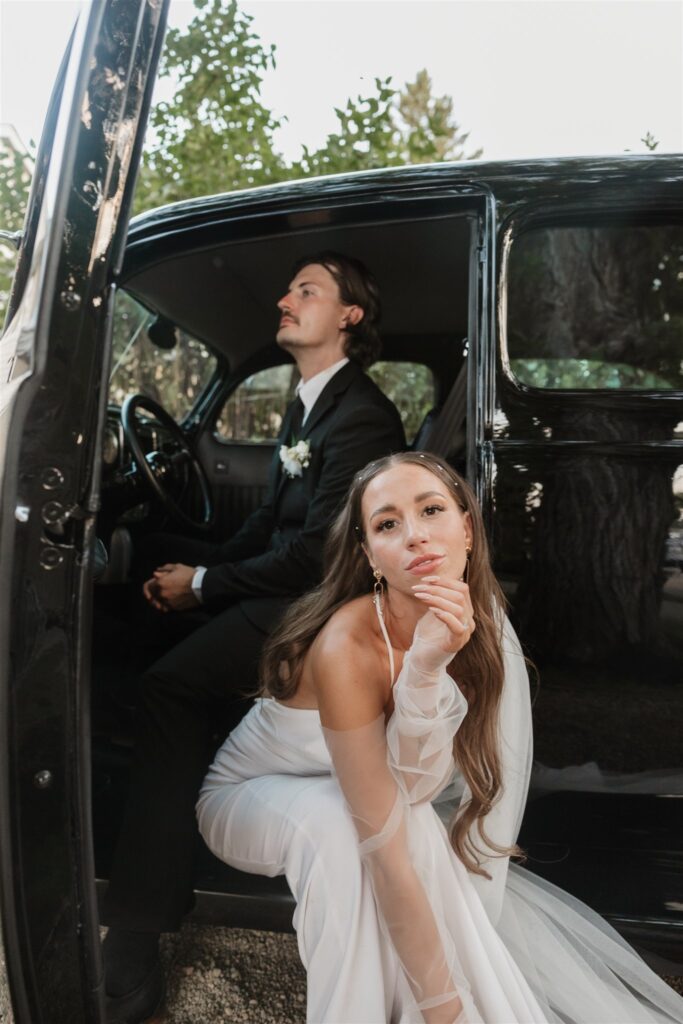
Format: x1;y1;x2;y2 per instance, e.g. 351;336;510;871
261;452;518;878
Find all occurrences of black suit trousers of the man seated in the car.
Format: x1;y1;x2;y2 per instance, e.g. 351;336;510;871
103;538;284;932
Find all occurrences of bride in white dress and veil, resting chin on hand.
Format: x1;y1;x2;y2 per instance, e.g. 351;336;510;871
198;453;683;1024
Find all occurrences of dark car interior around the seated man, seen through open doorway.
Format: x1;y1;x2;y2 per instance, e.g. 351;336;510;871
92;201;476;928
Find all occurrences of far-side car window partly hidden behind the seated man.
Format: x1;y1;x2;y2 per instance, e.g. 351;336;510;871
216;360;435;443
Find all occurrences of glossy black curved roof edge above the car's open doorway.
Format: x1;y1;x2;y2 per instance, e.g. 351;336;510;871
123;155;683;278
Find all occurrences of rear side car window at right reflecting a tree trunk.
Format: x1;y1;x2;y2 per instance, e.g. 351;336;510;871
507;224;683;390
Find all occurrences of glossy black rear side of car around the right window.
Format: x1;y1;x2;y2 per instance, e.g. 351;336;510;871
493;192;683;963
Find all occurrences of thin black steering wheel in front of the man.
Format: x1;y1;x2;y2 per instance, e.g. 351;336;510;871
121;394;214;530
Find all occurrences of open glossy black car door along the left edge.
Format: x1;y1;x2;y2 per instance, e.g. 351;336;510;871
0;0;167;1024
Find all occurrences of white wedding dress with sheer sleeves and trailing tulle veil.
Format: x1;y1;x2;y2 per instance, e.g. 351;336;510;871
198;607;683;1024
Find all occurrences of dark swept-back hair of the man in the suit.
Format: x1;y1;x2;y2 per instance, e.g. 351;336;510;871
293;250;382;370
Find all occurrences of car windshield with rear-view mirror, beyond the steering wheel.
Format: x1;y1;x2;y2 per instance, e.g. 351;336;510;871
110;292;216;420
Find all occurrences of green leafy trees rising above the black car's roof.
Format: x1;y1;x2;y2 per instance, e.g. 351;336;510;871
135;0;481;211
